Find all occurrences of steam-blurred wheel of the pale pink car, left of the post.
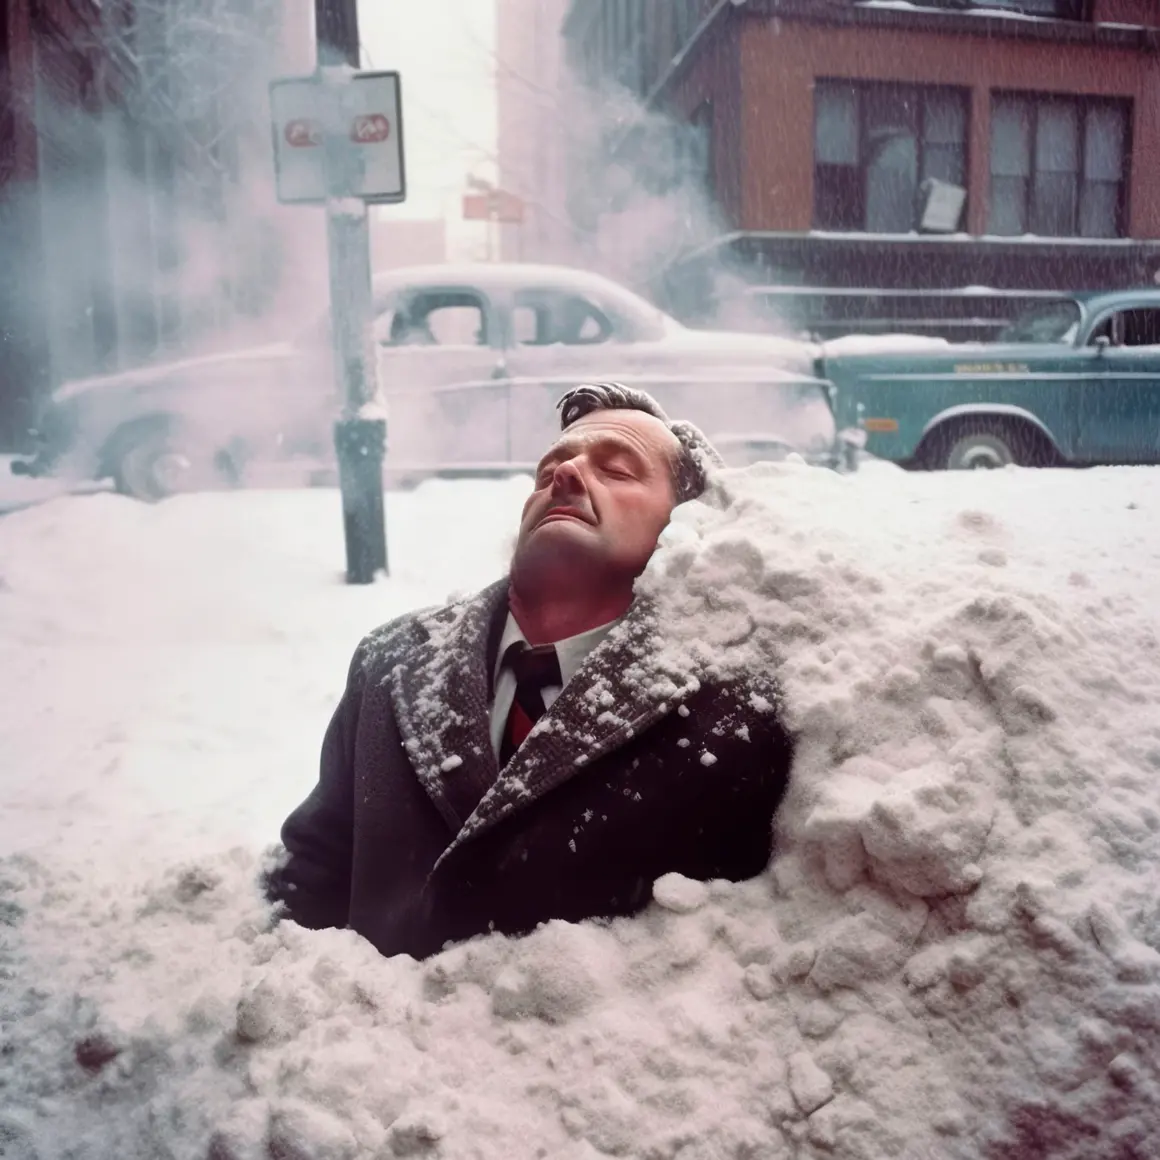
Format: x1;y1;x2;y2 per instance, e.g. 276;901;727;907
111;421;239;503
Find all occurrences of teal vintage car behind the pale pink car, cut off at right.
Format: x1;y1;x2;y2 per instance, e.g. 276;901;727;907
817;289;1160;469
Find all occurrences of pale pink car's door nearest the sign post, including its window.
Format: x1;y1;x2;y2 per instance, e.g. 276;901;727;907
375;284;507;472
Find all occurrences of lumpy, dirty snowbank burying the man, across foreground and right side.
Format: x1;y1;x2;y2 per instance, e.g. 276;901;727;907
0;463;1160;1160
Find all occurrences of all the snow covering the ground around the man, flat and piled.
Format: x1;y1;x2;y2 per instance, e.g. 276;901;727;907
0;464;1160;1160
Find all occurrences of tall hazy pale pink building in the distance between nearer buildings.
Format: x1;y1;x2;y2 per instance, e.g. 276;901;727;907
495;0;578;261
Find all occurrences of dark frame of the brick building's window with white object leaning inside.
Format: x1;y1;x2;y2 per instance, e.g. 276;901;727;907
811;77;973;233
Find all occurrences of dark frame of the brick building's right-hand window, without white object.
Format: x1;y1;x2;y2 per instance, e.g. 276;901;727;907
986;89;1136;241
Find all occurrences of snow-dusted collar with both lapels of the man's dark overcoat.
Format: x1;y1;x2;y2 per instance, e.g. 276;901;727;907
391;579;703;865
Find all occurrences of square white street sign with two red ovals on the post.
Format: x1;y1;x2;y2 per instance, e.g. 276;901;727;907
270;72;406;204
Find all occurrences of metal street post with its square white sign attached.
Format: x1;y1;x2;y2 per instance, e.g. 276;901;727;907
270;0;406;583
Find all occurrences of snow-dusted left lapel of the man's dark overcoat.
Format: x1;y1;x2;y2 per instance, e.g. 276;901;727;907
389;579;508;833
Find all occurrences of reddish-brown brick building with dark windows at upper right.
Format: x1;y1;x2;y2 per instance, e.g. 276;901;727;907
565;0;1160;338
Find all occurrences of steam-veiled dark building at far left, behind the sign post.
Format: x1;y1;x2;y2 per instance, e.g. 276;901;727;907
0;0;313;450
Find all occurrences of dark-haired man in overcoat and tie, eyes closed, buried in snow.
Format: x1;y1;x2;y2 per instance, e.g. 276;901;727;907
267;383;791;958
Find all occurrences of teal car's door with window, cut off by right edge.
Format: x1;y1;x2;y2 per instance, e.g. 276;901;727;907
1076;306;1160;463
